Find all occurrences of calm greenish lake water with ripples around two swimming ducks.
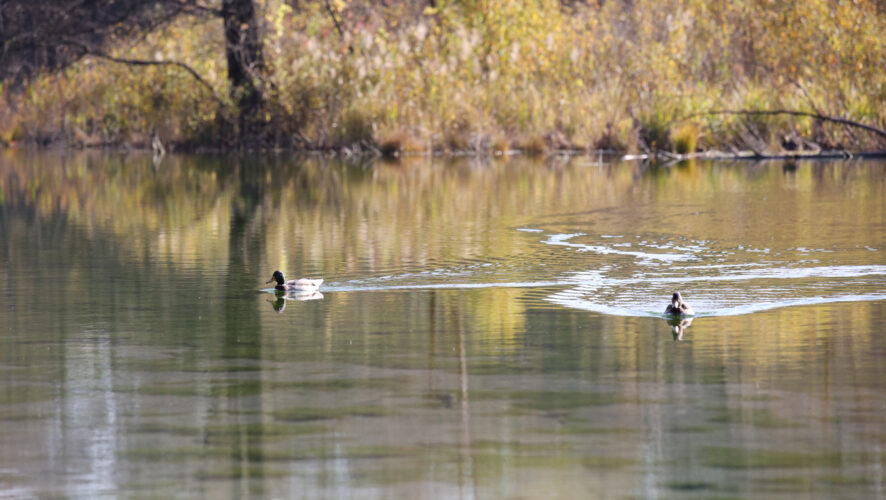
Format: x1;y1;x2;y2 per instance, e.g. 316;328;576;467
0;151;886;499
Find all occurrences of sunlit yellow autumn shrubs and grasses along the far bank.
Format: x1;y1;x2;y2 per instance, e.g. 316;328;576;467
0;0;886;153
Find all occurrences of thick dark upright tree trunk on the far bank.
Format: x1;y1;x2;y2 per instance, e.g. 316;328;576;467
222;0;263;144
